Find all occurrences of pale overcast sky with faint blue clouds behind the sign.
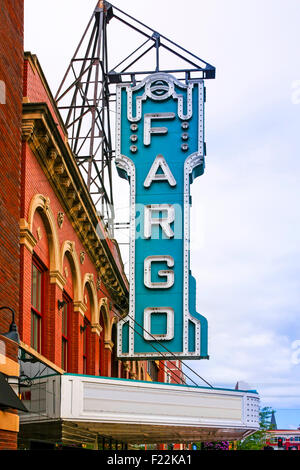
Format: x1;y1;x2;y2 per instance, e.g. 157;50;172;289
25;0;300;428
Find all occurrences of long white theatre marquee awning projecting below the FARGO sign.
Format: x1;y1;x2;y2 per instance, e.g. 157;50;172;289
21;374;259;443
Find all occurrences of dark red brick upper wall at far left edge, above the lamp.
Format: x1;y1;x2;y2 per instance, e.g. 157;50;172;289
0;0;23;332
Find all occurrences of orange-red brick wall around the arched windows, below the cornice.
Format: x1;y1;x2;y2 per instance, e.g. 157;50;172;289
20;143;113;373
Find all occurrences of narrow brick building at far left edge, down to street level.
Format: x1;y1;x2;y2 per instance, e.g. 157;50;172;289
0;0;23;449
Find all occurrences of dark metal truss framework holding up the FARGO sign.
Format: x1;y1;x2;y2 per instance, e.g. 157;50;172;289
55;1;215;236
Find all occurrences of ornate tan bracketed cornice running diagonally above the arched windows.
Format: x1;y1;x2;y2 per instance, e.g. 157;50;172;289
22;103;128;309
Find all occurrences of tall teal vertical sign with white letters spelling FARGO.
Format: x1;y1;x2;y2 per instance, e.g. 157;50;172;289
116;73;207;360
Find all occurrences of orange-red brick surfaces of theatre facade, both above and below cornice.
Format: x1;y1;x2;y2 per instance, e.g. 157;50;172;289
20;59;113;374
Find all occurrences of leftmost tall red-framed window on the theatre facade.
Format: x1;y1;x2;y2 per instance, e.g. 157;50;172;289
31;258;45;353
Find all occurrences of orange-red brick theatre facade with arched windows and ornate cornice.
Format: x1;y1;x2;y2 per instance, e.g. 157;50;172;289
19;53;182;445
